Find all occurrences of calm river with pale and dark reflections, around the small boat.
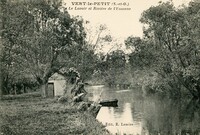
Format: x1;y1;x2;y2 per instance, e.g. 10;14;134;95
87;85;200;135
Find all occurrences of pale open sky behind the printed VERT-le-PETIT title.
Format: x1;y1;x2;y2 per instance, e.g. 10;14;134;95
64;0;191;52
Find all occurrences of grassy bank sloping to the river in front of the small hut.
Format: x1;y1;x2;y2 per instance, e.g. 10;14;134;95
0;94;108;135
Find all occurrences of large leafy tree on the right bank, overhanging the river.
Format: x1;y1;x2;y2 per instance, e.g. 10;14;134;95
128;1;200;98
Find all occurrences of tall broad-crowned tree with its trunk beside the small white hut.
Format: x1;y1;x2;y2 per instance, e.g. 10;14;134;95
2;0;86;97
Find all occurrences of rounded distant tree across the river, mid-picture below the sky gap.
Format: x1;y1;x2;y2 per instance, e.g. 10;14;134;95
96;50;127;86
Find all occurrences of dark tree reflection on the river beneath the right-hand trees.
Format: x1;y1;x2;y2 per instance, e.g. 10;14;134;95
143;99;200;135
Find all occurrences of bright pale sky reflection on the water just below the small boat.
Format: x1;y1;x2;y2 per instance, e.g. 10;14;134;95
97;103;141;134
